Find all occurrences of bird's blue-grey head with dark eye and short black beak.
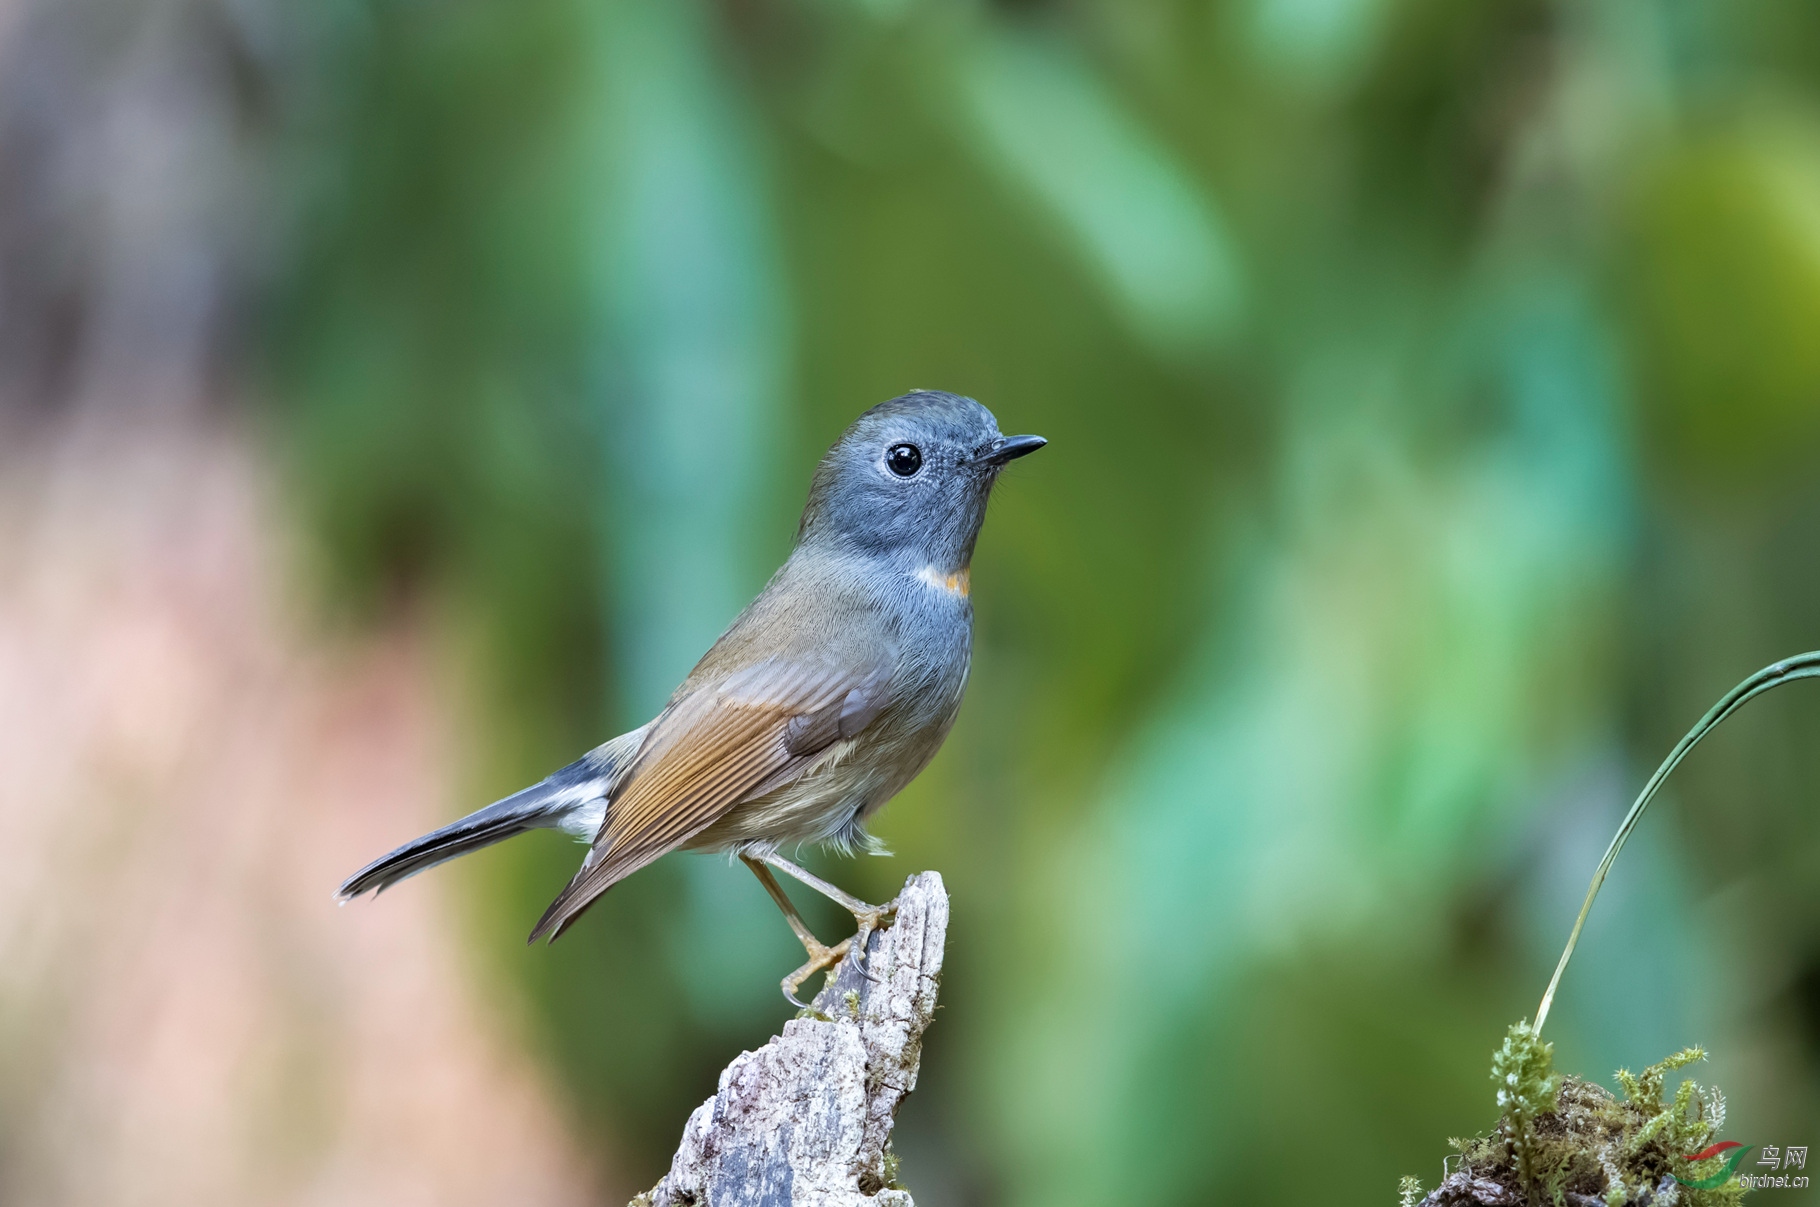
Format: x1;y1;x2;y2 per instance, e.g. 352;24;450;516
797;390;1047;570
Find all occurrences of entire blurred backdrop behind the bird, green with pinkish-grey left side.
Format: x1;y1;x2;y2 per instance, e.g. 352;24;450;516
0;0;1820;1207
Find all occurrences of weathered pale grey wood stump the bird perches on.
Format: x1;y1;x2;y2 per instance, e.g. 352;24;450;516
632;872;948;1207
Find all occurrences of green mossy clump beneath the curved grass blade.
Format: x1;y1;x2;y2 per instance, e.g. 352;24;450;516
1434;1023;1744;1207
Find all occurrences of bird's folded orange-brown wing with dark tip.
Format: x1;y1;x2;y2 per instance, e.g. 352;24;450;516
530;659;890;943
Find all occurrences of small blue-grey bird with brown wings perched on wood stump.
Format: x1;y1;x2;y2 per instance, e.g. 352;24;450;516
339;390;1047;1005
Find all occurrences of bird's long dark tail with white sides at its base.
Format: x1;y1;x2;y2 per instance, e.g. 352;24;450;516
335;734;633;901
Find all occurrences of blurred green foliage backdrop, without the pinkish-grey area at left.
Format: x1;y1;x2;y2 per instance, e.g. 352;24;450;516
3;0;1820;1207
